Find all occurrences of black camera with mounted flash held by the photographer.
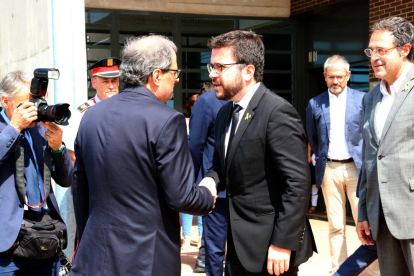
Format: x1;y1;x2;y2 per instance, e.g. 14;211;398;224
30;68;71;126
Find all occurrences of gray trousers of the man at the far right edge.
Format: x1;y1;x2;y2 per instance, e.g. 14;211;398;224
377;207;414;276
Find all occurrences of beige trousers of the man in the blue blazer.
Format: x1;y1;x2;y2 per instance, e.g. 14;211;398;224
321;161;358;272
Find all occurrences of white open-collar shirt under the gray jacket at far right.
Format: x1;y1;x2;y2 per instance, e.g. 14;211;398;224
375;62;412;140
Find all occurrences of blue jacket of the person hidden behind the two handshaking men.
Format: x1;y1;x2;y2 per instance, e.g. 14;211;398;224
188;90;227;197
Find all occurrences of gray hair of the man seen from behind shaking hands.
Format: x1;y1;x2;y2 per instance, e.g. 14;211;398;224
119;34;177;86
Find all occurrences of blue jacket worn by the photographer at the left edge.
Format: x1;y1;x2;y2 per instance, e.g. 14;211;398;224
0;107;73;252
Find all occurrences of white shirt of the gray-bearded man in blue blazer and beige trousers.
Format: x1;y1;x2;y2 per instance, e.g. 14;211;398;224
328;87;352;160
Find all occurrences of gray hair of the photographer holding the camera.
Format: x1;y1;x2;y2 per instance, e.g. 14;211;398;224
0;70;31;105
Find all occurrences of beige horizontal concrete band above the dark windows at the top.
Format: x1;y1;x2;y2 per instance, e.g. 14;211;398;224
85;0;290;17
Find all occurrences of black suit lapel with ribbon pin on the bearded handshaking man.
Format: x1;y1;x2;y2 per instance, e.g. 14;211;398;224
226;83;267;174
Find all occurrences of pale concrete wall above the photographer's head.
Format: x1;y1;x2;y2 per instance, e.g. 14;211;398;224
0;0;53;80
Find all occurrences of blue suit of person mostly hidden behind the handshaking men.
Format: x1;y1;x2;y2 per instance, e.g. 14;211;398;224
188;90;230;276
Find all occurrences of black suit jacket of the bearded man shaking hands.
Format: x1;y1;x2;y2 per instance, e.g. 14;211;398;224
206;84;316;273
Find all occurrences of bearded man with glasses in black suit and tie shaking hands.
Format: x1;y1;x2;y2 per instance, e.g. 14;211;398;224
201;30;316;275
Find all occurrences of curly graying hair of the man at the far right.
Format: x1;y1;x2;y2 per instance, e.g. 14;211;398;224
372;17;414;61
